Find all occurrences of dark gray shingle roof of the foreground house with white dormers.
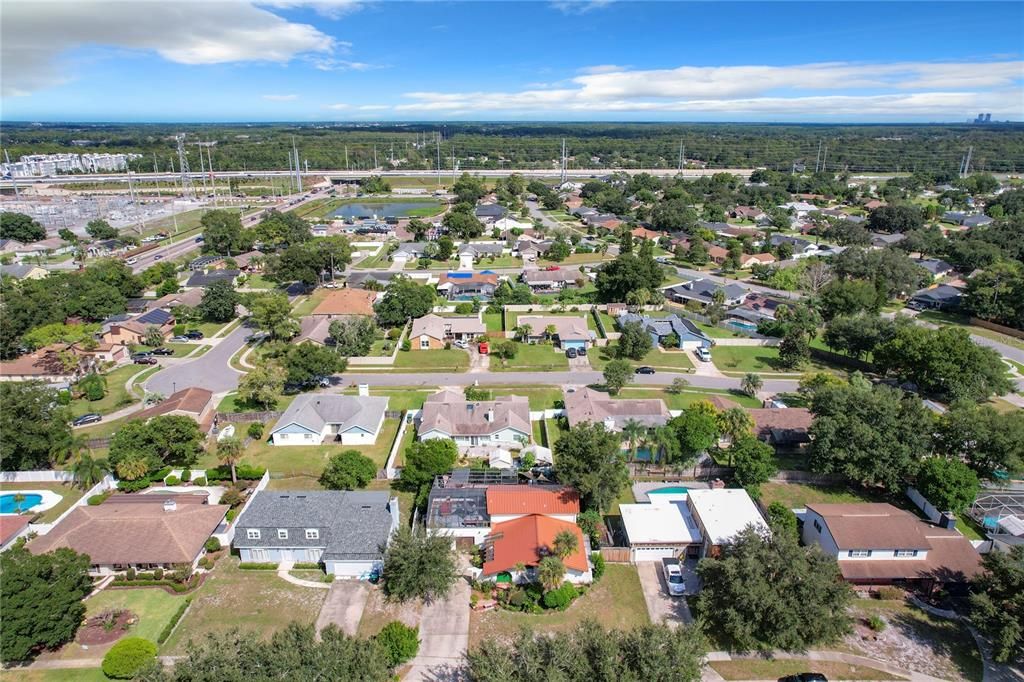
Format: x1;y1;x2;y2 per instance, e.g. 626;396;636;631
234;491;397;560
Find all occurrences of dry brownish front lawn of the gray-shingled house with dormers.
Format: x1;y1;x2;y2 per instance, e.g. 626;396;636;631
164;556;327;653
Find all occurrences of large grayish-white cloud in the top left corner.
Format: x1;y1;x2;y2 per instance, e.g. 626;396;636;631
0;0;342;95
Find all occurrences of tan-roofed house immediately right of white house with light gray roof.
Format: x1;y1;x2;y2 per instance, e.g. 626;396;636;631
418;390;532;447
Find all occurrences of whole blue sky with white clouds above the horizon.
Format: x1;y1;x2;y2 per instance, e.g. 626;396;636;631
0;0;1024;122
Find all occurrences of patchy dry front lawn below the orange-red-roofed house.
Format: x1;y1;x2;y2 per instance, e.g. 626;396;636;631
469;564;650;647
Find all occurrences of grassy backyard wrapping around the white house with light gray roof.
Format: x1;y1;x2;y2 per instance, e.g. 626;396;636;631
196;419;398;476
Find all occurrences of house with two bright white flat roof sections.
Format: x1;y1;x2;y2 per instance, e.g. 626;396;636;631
620;488;770;562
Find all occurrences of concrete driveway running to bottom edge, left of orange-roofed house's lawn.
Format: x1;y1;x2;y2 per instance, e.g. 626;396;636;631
404;578;470;682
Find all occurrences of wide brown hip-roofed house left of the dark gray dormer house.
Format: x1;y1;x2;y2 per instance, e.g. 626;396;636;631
28;493;228;577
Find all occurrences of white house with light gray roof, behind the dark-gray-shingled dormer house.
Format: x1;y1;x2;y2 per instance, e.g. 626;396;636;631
270;393;388;445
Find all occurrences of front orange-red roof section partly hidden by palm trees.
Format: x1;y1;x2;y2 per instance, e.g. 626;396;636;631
483;509;590;576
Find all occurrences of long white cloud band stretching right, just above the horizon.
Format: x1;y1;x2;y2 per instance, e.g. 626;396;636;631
395;61;1024;118
